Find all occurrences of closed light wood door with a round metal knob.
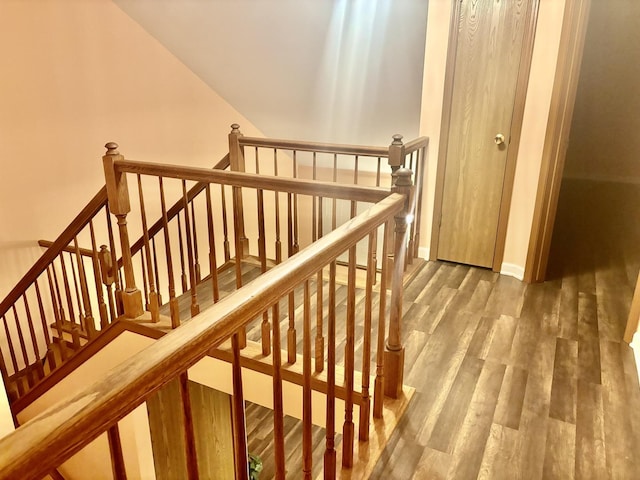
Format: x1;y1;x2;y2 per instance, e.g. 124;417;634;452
437;0;533;267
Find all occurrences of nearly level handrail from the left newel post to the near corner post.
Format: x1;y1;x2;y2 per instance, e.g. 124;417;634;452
114;160;389;203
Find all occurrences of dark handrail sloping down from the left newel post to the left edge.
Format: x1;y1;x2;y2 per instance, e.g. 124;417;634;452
0;187;107;317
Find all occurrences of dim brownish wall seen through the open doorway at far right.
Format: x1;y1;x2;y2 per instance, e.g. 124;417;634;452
565;0;640;183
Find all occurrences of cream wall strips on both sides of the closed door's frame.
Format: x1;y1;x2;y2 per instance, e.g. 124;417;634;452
420;0;565;279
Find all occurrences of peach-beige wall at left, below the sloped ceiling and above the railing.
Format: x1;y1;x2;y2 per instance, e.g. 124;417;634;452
0;0;260;298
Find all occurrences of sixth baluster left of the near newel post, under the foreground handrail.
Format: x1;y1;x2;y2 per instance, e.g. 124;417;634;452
271;301;286;479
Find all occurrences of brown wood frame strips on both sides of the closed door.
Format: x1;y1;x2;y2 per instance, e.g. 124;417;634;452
429;0;540;272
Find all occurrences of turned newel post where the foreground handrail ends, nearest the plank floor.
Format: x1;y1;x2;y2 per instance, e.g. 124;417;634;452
384;168;413;398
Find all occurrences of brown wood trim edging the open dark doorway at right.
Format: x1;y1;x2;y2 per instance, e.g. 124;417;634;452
524;0;591;283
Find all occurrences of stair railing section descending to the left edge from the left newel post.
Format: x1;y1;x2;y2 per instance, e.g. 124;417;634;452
0;188;120;398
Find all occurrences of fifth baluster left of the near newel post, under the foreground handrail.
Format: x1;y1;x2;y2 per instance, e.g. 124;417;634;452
302;280;313;480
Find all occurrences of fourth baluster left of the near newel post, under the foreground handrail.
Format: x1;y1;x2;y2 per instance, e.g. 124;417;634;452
324;261;336;479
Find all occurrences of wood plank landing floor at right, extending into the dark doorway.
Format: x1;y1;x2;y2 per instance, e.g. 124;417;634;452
371;181;640;480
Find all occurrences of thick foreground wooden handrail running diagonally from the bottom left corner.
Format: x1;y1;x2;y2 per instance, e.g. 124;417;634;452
0;194;405;479
